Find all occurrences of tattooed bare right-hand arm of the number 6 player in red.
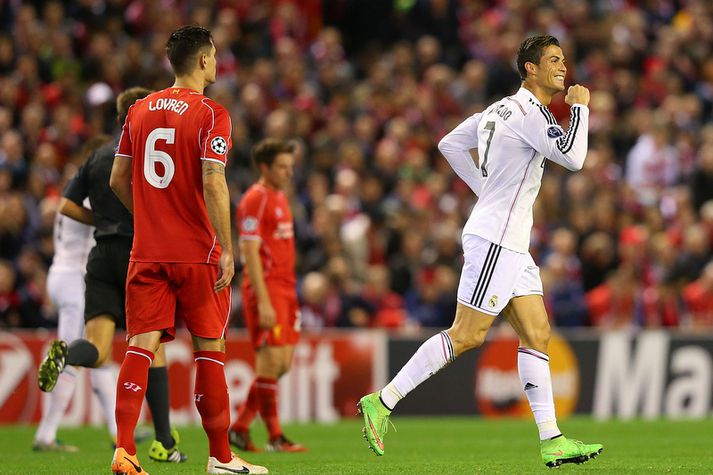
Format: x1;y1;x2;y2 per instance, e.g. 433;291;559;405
202;160;235;292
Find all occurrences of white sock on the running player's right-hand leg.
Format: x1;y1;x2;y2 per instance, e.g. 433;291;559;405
517;347;562;440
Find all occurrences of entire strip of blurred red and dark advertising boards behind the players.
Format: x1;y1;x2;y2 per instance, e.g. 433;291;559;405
0;326;713;425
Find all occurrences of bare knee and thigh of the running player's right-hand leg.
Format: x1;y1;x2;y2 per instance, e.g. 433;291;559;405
503;294;550;353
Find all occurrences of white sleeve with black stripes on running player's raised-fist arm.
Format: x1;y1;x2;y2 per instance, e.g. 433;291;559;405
519;104;589;171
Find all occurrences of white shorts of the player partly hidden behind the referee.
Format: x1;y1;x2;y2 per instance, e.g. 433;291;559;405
47;270;84;343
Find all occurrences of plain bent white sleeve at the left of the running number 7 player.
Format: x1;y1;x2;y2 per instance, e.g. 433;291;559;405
438;113;483;196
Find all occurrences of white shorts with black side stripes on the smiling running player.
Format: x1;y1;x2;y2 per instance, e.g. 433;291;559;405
458;234;543;316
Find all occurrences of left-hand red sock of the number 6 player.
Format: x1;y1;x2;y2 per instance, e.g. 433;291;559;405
114;346;154;455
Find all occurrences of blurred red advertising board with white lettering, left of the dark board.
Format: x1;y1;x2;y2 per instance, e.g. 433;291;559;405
0;331;387;425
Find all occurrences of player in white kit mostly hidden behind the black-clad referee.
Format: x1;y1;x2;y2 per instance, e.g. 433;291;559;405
32;193;116;452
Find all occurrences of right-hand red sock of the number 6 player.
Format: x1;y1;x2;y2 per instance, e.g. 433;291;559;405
193;351;232;463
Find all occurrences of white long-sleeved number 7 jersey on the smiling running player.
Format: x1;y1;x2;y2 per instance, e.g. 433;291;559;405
438;87;589;253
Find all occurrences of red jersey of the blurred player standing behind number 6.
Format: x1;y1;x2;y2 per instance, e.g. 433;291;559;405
237;183;297;285
